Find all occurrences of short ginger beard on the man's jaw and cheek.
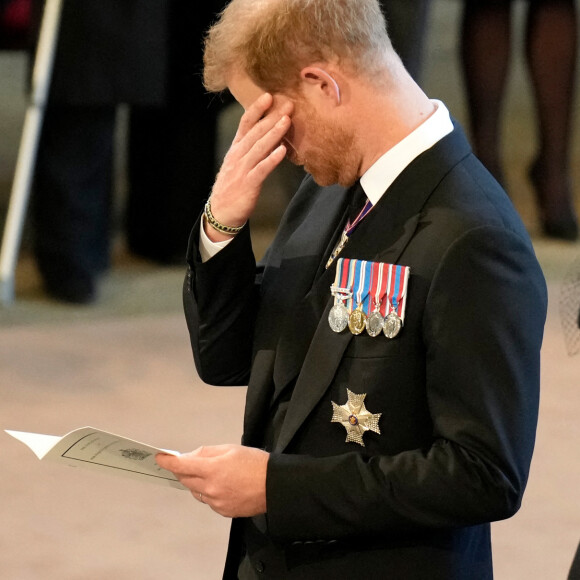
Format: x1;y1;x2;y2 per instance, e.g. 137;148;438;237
287;104;359;187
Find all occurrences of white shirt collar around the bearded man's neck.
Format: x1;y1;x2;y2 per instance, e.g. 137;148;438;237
360;99;453;205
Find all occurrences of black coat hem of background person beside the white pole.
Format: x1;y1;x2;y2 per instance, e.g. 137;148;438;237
50;0;168;106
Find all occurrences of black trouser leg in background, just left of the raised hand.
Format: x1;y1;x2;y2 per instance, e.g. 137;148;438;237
126;0;225;264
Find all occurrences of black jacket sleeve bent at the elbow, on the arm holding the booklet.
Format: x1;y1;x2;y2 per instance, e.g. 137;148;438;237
267;227;546;540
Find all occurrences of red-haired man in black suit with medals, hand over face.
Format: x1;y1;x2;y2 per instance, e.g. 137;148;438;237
158;0;546;580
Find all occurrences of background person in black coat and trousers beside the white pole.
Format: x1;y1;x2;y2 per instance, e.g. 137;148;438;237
32;0;222;303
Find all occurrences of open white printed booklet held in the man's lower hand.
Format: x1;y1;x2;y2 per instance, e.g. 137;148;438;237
5;427;187;490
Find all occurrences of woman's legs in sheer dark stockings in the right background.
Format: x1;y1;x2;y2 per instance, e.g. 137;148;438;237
461;0;578;241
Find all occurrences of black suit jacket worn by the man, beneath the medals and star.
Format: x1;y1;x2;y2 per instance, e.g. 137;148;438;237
184;128;547;580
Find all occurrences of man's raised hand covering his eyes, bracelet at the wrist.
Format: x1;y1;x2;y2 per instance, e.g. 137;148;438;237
205;93;293;242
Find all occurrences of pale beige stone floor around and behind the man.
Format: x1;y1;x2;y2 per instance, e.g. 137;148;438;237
0;0;580;580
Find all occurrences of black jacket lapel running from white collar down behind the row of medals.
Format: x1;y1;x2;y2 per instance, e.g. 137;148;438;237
274;129;471;452
